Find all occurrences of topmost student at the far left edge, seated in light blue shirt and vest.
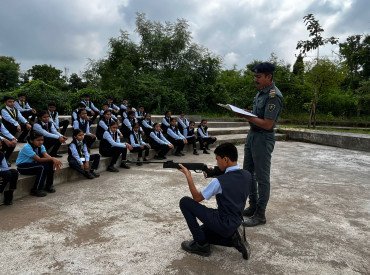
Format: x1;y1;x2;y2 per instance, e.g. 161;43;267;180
1;96;32;143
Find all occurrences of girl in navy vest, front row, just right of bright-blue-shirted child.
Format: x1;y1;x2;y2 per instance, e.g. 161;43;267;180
68;129;100;179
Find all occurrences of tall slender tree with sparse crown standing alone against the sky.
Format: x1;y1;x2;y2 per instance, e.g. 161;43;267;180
296;13;338;128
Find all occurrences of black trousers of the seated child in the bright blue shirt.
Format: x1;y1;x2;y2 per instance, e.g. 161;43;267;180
17;162;54;191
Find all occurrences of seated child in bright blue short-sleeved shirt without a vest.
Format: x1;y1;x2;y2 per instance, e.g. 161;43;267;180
16;131;62;197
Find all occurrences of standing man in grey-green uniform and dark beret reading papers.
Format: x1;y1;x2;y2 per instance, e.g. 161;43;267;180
243;62;283;227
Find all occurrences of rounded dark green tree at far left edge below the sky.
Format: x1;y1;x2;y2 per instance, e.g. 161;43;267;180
0;56;19;91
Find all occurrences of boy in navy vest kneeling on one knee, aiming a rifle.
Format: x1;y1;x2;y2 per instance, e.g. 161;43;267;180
180;143;252;260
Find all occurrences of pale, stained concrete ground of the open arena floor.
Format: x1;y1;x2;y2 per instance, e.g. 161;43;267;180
0;142;370;274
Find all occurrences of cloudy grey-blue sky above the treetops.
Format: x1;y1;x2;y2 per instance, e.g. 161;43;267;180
0;0;370;75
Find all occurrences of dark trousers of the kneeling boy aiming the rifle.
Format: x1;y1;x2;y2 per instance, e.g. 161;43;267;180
180;197;238;246
